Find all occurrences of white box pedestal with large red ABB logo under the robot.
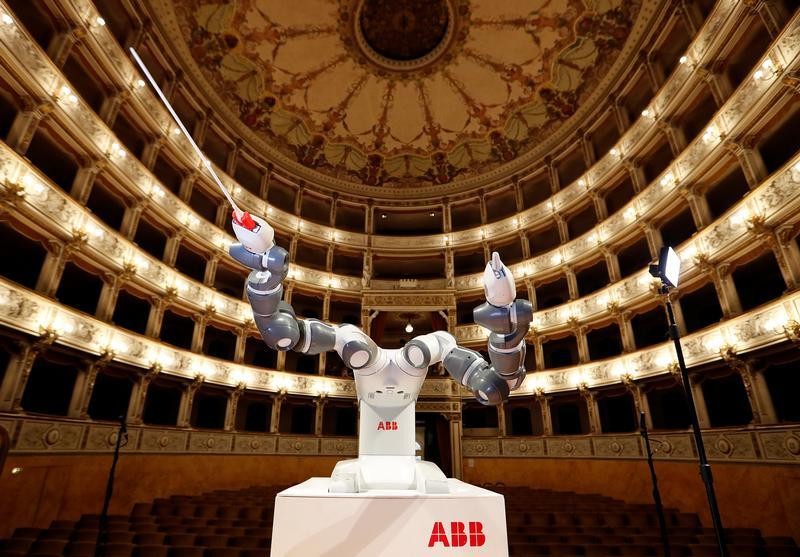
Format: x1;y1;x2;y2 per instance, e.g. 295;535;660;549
270;478;508;557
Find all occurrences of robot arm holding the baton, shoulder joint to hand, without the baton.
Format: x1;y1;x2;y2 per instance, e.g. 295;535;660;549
229;213;379;370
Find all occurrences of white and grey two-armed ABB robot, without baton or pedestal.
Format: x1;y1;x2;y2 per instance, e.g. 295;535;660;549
230;211;532;493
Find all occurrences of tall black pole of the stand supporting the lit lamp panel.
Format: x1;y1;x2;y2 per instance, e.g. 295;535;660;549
661;284;728;557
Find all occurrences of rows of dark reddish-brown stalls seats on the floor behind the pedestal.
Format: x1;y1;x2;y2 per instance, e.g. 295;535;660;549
0;485;800;557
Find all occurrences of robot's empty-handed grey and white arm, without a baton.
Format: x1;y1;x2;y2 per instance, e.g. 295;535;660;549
443;252;533;405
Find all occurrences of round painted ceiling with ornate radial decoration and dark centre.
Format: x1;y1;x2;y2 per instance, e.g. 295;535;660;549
173;0;642;187
